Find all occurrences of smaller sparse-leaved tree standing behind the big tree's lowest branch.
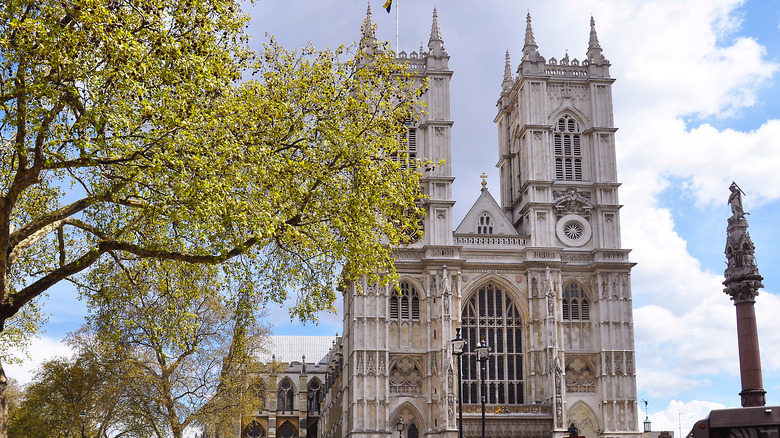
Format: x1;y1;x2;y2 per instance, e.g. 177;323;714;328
90;259;264;438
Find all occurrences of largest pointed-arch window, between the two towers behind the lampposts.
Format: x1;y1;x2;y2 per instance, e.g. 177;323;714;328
461;284;523;404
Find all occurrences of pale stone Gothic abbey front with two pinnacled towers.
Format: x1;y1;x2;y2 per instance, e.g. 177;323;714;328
317;9;639;438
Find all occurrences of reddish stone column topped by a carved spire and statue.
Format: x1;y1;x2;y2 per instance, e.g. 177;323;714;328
723;183;766;407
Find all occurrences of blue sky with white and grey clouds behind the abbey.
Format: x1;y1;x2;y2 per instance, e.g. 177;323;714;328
7;0;780;434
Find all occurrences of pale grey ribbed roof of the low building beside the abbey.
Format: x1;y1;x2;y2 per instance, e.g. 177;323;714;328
258;336;336;363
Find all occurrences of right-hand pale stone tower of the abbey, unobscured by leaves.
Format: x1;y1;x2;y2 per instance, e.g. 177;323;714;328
495;14;637;436
